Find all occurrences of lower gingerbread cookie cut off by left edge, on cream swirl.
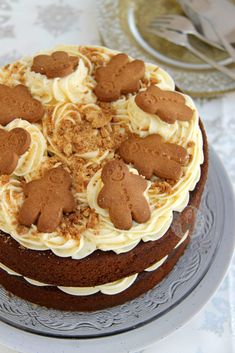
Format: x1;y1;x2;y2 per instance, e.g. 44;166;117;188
0;128;31;175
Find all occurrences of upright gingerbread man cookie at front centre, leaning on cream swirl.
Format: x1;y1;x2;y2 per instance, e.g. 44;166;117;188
97;160;150;230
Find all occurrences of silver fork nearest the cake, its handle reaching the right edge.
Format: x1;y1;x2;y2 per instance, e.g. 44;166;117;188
147;27;235;80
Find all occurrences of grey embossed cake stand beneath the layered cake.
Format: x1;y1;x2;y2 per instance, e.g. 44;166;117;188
0;149;235;353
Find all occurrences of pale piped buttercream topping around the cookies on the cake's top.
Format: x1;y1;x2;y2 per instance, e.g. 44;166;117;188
0;46;203;259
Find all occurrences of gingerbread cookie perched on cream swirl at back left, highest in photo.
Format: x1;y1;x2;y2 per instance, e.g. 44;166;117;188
31;51;79;78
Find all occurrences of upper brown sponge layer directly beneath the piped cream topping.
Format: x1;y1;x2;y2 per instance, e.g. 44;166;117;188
0;122;208;286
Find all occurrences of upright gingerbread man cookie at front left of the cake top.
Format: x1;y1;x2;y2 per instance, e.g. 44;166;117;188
19;167;75;233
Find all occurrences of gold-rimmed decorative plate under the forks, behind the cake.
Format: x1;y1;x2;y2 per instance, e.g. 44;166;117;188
97;0;235;97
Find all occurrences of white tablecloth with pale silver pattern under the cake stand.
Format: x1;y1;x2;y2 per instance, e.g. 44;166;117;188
0;0;235;353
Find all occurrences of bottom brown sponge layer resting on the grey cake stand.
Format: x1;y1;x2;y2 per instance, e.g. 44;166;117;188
0;236;190;311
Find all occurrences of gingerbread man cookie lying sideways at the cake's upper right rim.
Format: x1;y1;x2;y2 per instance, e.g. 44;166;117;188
135;85;193;124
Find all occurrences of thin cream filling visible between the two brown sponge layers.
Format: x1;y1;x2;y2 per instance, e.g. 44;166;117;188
0;231;189;296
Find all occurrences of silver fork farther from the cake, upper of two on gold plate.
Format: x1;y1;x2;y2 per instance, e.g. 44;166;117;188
149;15;224;50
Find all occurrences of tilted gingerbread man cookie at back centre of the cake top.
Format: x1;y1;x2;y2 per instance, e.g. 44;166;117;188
94;54;145;102
